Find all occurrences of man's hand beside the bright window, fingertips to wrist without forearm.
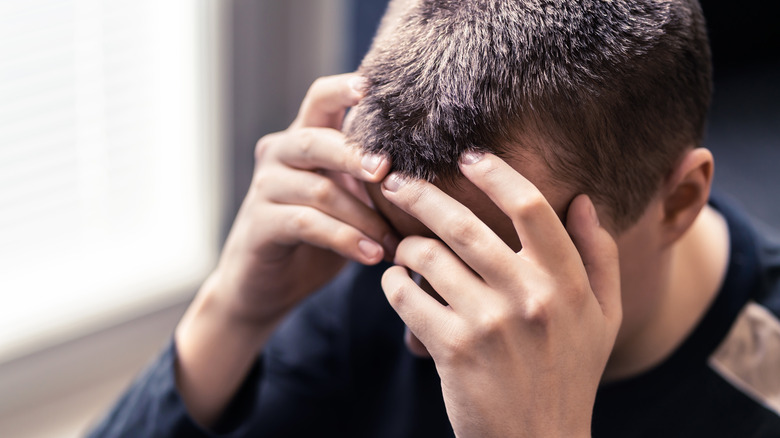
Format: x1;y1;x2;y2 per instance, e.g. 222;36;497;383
215;74;397;324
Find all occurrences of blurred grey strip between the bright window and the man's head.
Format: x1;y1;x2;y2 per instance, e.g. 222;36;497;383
223;0;351;235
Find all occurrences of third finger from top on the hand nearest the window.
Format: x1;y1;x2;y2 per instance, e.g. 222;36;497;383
266;169;398;255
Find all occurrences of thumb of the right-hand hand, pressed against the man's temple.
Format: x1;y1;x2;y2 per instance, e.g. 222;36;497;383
566;195;622;325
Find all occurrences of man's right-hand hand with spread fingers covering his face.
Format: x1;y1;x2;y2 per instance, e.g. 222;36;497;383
382;153;622;437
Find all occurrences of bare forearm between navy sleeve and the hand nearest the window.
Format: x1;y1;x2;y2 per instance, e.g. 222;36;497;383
175;277;276;427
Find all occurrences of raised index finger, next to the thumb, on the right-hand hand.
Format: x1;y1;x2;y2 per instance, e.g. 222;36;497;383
460;152;575;268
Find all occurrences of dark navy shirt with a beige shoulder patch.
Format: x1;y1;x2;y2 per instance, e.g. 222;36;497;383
90;197;780;438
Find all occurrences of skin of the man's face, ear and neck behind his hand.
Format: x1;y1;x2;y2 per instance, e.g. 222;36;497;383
368;148;728;380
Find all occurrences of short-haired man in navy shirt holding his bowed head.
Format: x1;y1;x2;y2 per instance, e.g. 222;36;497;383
88;0;780;437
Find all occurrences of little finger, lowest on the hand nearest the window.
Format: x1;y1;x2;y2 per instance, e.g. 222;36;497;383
275;205;384;265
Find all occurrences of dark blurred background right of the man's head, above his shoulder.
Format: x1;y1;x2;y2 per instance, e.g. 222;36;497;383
702;0;780;228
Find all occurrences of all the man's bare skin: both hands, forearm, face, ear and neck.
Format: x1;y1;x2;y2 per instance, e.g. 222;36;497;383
175;75;728;437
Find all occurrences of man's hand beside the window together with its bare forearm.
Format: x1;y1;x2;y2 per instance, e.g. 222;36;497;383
175;74;398;426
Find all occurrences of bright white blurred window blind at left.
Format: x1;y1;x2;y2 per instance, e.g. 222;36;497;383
0;0;219;362
